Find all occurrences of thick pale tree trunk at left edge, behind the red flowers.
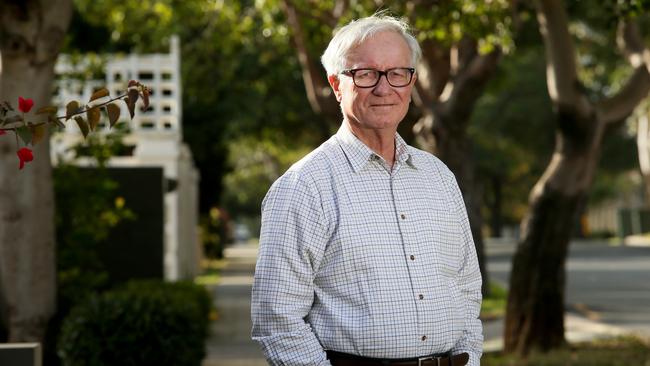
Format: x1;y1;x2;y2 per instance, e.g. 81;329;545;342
0;0;72;342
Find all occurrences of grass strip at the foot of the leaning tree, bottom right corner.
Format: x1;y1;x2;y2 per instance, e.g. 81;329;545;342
481;336;650;366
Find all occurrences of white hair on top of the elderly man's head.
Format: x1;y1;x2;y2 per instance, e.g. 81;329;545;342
321;13;422;75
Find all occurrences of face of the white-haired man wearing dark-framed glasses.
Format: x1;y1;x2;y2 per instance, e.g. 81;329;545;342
329;32;415;130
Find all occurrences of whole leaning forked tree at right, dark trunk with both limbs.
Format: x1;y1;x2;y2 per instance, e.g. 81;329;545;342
504;0;650;355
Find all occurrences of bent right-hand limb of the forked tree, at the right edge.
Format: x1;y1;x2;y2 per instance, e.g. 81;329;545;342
596;21;650;124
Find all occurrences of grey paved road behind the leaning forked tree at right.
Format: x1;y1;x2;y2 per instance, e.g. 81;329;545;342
487;242;650;337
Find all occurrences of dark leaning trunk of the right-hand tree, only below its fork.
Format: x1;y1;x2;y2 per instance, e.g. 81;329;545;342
504;101;606;355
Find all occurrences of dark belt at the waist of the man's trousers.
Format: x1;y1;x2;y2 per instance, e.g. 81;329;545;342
327;351;469;366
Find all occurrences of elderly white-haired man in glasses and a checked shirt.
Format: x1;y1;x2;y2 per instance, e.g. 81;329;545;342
252;15;482;366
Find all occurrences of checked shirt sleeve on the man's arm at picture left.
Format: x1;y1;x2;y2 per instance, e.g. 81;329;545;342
251;173;330;366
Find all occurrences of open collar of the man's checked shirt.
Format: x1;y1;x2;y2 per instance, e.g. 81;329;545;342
335;123;415;173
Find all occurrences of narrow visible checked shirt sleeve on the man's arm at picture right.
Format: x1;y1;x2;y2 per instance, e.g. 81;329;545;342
451;175;483;366
